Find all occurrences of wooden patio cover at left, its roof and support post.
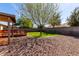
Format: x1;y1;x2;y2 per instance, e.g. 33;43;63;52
0;12;16;42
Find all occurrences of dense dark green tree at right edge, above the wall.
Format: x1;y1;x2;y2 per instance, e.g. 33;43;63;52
67;7;79;26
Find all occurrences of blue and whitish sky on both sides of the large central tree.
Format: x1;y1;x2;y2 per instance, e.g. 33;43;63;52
0;3;79;23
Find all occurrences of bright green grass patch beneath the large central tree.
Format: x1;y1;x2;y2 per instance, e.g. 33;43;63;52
27;32;58;38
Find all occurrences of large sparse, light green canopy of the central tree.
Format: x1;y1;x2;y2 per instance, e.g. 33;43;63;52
14;3;59;28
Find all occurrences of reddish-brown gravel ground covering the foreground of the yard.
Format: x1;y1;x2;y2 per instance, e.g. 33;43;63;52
0;35;79;56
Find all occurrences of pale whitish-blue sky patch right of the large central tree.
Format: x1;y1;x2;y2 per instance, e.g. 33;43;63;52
59;3;79;23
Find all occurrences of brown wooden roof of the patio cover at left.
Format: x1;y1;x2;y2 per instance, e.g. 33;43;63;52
0;12;16;23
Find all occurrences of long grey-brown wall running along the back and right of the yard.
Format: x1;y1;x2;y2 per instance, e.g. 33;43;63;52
19;27;79;37
